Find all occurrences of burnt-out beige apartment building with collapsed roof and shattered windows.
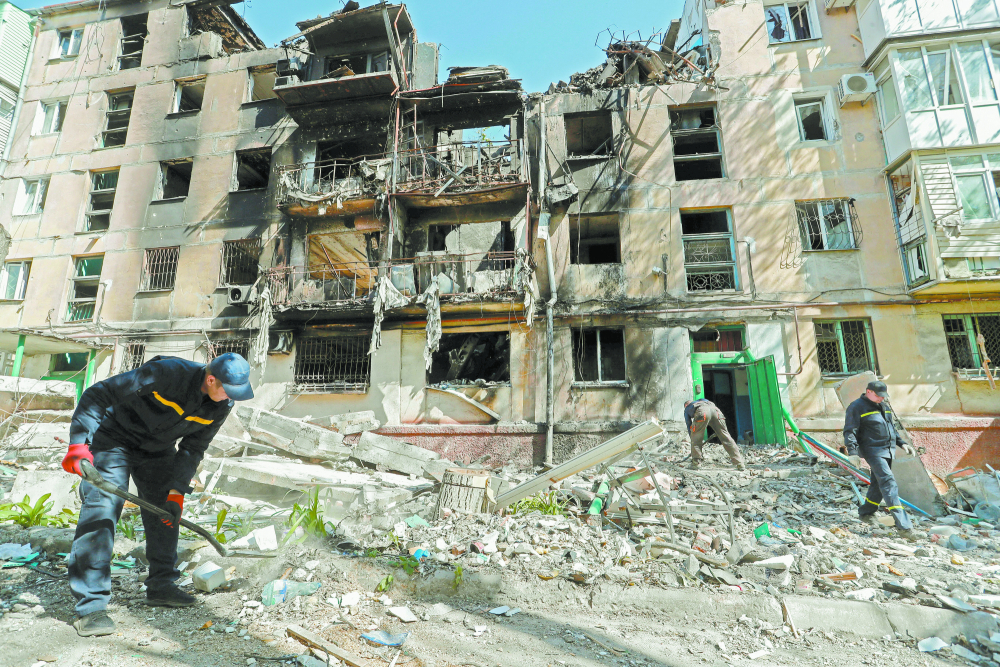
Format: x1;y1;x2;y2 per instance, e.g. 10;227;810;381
0;0;1000;474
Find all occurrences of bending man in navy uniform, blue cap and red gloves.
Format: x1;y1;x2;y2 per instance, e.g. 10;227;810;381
62;352;253;637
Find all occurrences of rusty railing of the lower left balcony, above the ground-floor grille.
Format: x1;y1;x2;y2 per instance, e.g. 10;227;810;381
264;262;378;306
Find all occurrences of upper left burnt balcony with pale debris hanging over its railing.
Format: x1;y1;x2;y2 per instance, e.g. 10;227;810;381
278;155;392;219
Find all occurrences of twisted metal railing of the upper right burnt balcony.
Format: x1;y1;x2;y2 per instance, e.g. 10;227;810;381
396;140;527;195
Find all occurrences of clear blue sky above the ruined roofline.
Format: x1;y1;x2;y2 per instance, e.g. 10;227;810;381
16;0;684;92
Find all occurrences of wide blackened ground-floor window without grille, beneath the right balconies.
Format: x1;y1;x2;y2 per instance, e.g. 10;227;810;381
427;331;510;384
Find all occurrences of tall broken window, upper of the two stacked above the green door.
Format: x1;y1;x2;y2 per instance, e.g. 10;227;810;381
670;106;725;181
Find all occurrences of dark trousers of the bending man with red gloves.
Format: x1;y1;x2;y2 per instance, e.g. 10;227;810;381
69;447;180;616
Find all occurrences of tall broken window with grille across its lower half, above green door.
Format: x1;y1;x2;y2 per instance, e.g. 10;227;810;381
681;209;739;292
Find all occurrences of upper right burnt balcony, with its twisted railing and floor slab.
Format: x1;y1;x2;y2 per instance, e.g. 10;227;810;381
394;140;528;208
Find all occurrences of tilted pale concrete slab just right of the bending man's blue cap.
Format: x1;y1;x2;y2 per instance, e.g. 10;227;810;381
236;405;351;460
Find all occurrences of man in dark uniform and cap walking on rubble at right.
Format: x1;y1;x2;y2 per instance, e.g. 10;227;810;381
844;380;916;538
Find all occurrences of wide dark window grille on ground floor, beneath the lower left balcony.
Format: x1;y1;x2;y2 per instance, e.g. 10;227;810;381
295;336;371;393
